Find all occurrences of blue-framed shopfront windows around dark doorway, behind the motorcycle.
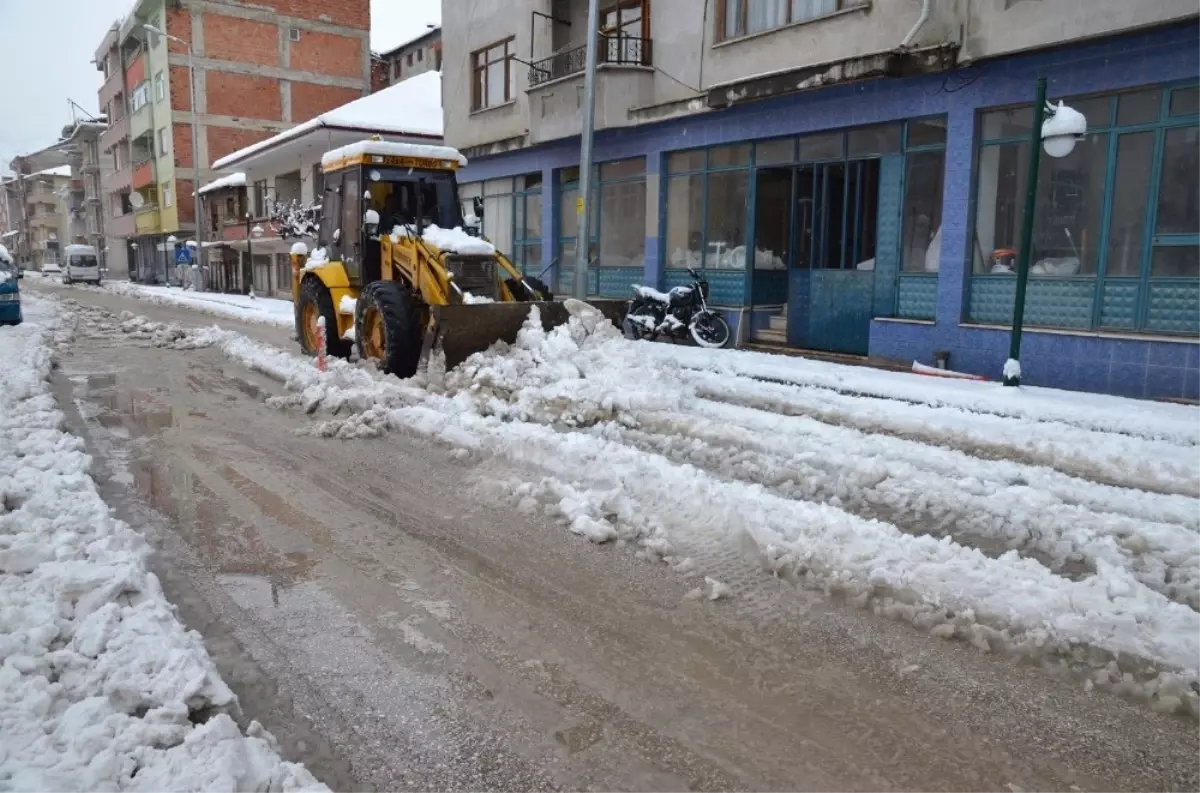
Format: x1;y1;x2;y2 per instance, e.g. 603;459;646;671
660;116;946;311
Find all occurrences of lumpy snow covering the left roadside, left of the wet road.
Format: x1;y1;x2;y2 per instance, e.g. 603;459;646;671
0;298;328;793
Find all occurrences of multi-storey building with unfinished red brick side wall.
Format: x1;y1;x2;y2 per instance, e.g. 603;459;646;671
96;0;371;281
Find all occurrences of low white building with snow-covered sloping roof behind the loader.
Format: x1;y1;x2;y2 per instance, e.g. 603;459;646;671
200;72;443;298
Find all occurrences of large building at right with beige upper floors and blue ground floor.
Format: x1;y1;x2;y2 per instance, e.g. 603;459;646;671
443;0;1200;398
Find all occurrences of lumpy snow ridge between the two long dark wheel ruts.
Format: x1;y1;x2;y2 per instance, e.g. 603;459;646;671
600;405;1200;608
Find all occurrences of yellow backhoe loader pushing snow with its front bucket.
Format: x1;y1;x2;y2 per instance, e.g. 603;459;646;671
285;140;625;377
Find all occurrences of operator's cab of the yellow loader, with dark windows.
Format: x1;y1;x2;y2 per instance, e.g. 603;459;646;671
319;146;463;287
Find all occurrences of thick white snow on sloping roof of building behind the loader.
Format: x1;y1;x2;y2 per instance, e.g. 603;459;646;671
212;72;442;170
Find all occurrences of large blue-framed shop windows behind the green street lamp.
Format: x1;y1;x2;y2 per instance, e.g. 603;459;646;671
966;84;1200;334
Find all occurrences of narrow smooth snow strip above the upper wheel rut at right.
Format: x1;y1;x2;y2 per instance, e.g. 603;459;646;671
688;372;1200;498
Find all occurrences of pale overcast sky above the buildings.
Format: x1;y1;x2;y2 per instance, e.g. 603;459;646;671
0;0;442;172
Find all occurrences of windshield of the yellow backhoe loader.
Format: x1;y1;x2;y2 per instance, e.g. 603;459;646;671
364;168;462;233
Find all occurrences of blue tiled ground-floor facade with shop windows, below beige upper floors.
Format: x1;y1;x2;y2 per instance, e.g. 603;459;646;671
460;24;1200;399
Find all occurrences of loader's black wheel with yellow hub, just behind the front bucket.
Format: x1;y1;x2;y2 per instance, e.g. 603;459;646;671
354;281;424;378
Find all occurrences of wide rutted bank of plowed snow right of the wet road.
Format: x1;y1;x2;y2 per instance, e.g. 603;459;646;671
72;301;1200;716
